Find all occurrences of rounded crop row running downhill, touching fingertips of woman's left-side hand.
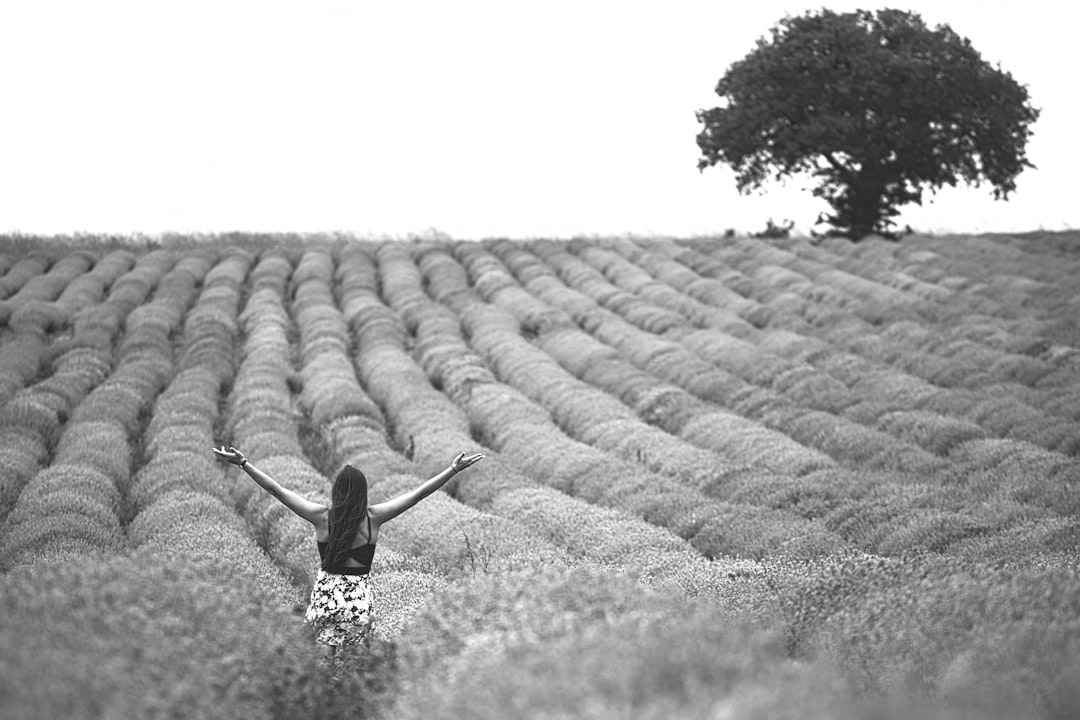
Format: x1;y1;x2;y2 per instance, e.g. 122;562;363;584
129;245;302;602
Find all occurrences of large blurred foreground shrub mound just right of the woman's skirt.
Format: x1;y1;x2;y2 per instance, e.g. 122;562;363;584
391;568;907;720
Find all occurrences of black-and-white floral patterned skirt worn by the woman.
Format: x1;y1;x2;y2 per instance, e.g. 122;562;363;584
303;570;375;646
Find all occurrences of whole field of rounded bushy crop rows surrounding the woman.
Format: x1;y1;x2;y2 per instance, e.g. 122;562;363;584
0;233;1080;720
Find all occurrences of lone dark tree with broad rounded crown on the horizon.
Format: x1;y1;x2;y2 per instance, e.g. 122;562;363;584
698;10;1039;240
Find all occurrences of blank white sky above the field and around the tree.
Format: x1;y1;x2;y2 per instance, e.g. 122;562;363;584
0;0;1080;237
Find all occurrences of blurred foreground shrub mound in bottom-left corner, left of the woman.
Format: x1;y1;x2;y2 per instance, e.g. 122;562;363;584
0;552;394;720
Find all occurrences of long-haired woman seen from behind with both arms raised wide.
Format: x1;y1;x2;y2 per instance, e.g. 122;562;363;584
214;445;484;656
